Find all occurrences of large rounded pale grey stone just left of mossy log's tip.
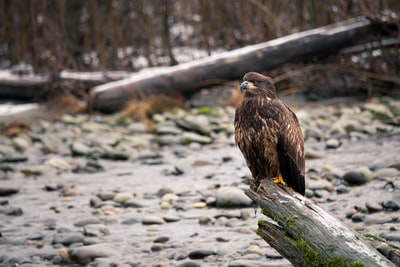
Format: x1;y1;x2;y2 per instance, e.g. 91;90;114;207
216;186;252;208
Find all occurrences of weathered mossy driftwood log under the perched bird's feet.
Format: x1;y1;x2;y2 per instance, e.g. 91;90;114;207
246;179;395;267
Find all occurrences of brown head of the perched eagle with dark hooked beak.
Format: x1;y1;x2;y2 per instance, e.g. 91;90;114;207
240;72;276;98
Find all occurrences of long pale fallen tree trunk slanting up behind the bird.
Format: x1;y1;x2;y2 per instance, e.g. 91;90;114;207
89;17;396;113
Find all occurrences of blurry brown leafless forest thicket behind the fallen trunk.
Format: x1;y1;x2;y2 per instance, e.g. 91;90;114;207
0;0;400;102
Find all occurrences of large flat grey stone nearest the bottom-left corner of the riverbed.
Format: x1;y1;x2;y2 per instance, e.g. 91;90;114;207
69;244;117;264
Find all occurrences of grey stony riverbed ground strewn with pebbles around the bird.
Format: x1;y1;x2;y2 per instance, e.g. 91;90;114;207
0;98;400;266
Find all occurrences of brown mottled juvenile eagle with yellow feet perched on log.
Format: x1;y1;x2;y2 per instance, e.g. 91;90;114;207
235;72;305;195
